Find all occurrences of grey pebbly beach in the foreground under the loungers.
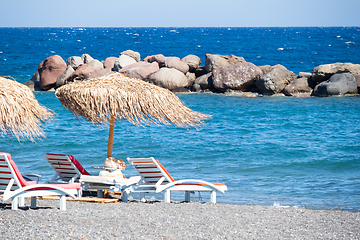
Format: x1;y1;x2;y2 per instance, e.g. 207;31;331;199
0;199;360;239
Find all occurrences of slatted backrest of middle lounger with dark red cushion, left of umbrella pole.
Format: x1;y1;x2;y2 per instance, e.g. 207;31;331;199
44;153;90;183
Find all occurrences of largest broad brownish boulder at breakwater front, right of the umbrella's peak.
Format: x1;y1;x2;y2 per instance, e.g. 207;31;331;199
212;62;262;91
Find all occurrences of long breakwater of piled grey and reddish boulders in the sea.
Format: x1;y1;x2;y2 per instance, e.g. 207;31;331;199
25;50;360;97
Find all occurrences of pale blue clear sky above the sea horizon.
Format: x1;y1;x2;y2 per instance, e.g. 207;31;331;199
0;0;360;27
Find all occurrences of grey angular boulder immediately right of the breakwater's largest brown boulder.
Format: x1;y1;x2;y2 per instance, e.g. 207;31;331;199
255;65;297;95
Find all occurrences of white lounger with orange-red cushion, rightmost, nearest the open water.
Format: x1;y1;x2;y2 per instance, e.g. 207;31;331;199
121;157;227;203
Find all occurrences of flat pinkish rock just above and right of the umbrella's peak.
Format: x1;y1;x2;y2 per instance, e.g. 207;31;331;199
119;61;159;80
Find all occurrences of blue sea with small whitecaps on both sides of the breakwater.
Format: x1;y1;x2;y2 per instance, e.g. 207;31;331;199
0;27;360;212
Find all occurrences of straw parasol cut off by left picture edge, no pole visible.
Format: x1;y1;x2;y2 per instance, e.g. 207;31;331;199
0;77;53;141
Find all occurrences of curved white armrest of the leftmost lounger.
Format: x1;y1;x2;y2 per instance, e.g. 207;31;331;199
3;183;75;201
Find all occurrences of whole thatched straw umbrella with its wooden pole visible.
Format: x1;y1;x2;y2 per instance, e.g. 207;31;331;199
55;73;208;157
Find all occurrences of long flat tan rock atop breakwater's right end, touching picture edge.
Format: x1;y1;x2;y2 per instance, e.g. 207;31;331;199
312;63;360;83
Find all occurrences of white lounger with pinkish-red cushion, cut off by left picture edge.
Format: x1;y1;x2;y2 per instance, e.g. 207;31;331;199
0;152;81;210
